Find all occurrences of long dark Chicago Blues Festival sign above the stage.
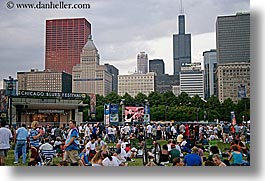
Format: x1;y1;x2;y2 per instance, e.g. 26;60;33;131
18;90;86;99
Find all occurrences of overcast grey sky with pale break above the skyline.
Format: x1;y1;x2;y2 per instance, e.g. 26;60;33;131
0;0;250;88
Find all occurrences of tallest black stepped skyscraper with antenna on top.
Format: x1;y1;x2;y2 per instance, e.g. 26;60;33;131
173;2;191;74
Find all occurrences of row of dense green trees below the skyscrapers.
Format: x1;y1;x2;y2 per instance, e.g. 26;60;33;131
83;91;250;122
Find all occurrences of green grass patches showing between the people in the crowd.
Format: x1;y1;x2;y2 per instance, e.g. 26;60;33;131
5;140;234;166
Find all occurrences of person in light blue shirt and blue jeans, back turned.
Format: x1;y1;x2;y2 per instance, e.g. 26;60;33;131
14;123;29;164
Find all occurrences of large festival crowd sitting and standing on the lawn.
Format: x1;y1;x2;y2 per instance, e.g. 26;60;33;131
0;120;250;166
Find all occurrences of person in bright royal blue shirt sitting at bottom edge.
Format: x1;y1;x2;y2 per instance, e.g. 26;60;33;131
183;146;202;166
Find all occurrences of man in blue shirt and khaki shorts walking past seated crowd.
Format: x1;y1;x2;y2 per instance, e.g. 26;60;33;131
63;120;83;166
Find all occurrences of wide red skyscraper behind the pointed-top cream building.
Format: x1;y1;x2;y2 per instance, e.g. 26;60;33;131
45;18;91;74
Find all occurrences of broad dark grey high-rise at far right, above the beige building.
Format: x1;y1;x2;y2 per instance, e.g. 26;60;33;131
216;13;250;64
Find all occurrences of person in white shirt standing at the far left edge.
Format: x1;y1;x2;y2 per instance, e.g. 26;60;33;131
0;121;13;166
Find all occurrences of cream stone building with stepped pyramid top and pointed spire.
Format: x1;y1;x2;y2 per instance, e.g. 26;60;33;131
72;36;112;96
